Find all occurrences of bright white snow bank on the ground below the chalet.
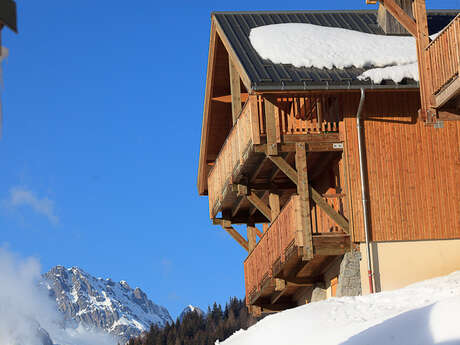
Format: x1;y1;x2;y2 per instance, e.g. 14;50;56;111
218;271;460;345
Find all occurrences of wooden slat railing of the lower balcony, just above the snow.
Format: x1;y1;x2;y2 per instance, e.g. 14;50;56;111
244;195;343;301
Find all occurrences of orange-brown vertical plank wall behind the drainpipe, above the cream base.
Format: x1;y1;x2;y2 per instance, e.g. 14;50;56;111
342;92;460;242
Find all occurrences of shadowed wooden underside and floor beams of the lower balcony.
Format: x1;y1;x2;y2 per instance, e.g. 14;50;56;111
248;233;351;312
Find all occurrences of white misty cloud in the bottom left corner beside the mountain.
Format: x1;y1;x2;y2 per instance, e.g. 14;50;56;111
0;248;117;345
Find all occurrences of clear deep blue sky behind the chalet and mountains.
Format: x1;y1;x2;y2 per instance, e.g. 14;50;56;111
0;0;460;317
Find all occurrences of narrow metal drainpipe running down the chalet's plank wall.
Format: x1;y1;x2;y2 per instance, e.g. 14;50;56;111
356;88;374;293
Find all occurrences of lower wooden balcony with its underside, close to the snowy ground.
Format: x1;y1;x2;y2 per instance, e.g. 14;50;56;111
244;195;351;311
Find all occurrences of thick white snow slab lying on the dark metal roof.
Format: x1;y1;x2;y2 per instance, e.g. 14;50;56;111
249;23;418;83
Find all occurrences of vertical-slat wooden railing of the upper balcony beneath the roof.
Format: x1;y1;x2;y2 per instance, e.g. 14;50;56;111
208;96;339;218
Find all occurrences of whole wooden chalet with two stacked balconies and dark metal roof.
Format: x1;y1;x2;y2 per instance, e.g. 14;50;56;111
198;1;460;312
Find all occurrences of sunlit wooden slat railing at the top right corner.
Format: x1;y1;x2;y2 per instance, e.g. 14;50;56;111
426;14;460;101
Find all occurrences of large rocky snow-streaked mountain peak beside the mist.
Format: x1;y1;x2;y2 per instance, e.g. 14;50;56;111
43;266;172;340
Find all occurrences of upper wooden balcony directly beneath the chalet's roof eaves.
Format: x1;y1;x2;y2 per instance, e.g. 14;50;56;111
208;95;342;218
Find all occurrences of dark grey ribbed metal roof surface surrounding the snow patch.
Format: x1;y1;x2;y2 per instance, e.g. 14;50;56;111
213;10;459;91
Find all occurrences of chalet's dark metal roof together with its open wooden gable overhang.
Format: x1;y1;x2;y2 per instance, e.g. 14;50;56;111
198;10;458;195
